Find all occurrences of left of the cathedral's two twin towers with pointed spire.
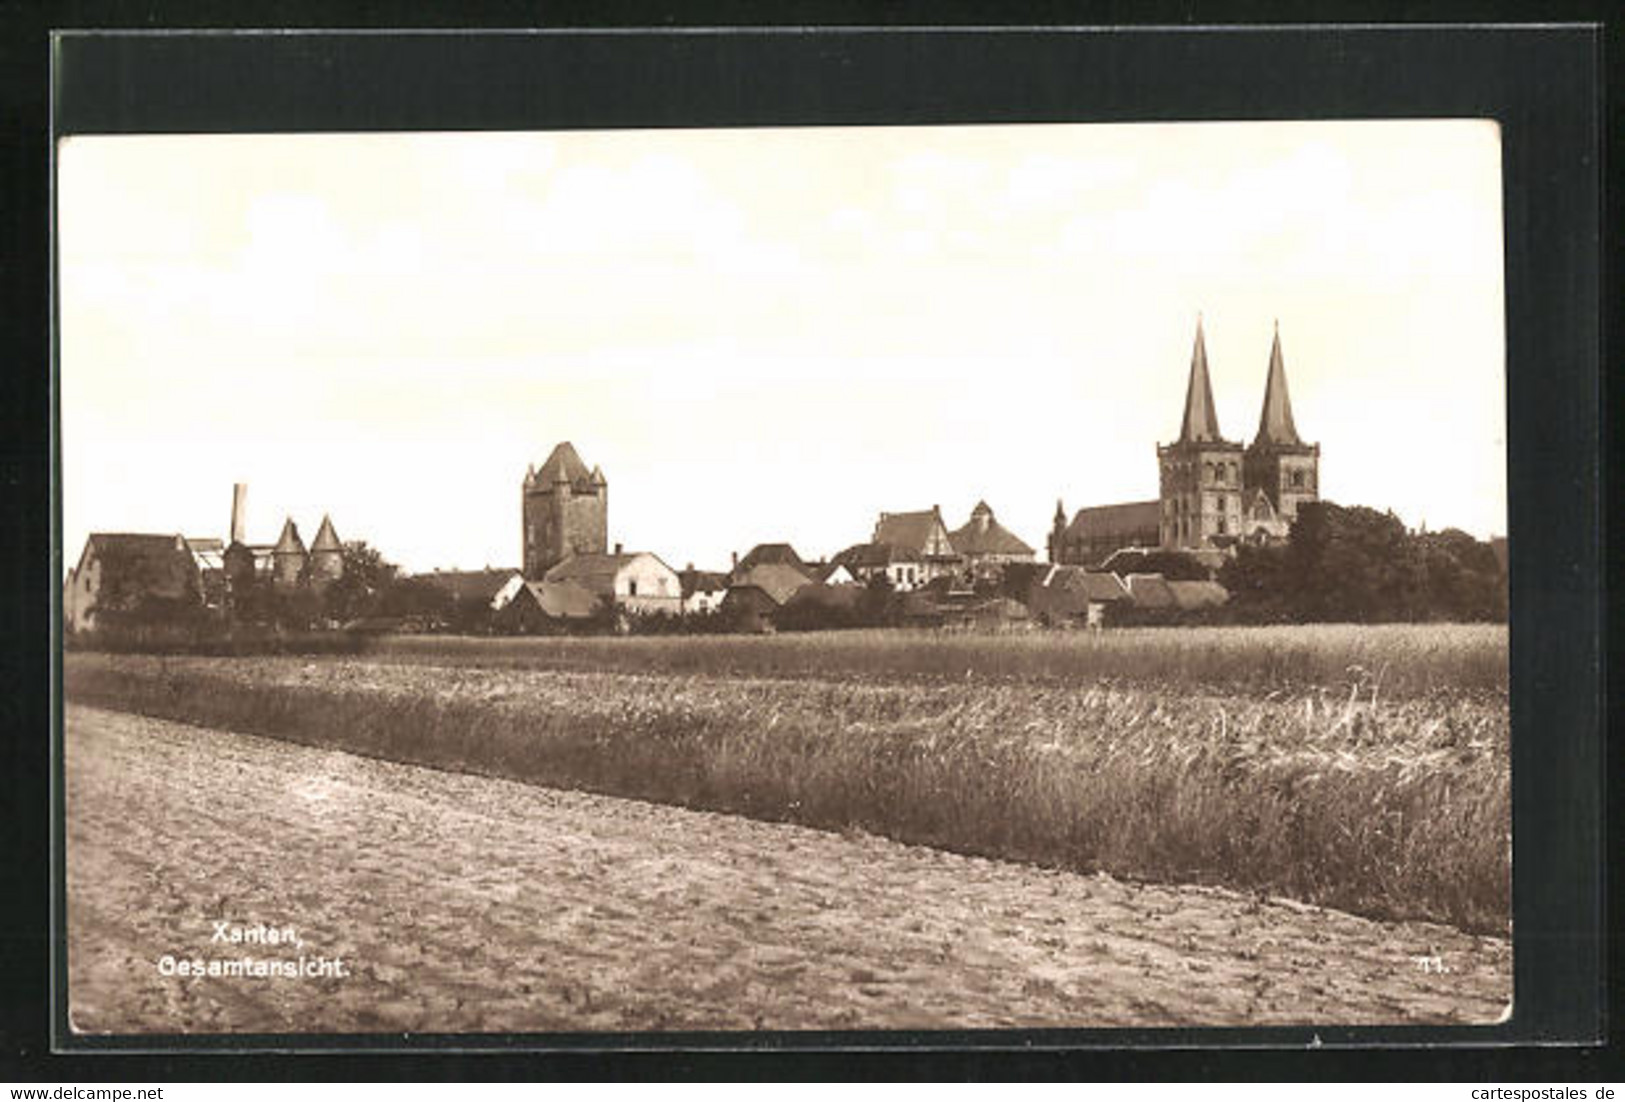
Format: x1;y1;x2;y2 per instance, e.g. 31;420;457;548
1157;315;1242;549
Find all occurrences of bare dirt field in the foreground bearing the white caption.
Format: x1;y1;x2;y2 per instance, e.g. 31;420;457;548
67;707;1511;1032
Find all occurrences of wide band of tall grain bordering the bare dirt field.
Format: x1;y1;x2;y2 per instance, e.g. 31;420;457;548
65;653;1510;933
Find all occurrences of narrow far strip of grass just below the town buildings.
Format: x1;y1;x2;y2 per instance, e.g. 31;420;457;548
369;624;1508;697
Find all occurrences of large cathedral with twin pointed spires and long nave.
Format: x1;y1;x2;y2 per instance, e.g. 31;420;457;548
1050;317;1320;566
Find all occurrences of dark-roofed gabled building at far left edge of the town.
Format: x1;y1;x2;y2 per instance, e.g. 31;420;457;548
62;531;203;632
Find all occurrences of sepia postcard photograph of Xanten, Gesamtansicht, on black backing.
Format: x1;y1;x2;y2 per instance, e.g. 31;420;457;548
55;119;1523;1037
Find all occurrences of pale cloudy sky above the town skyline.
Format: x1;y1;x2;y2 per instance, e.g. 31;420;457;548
59;120;1506;569
